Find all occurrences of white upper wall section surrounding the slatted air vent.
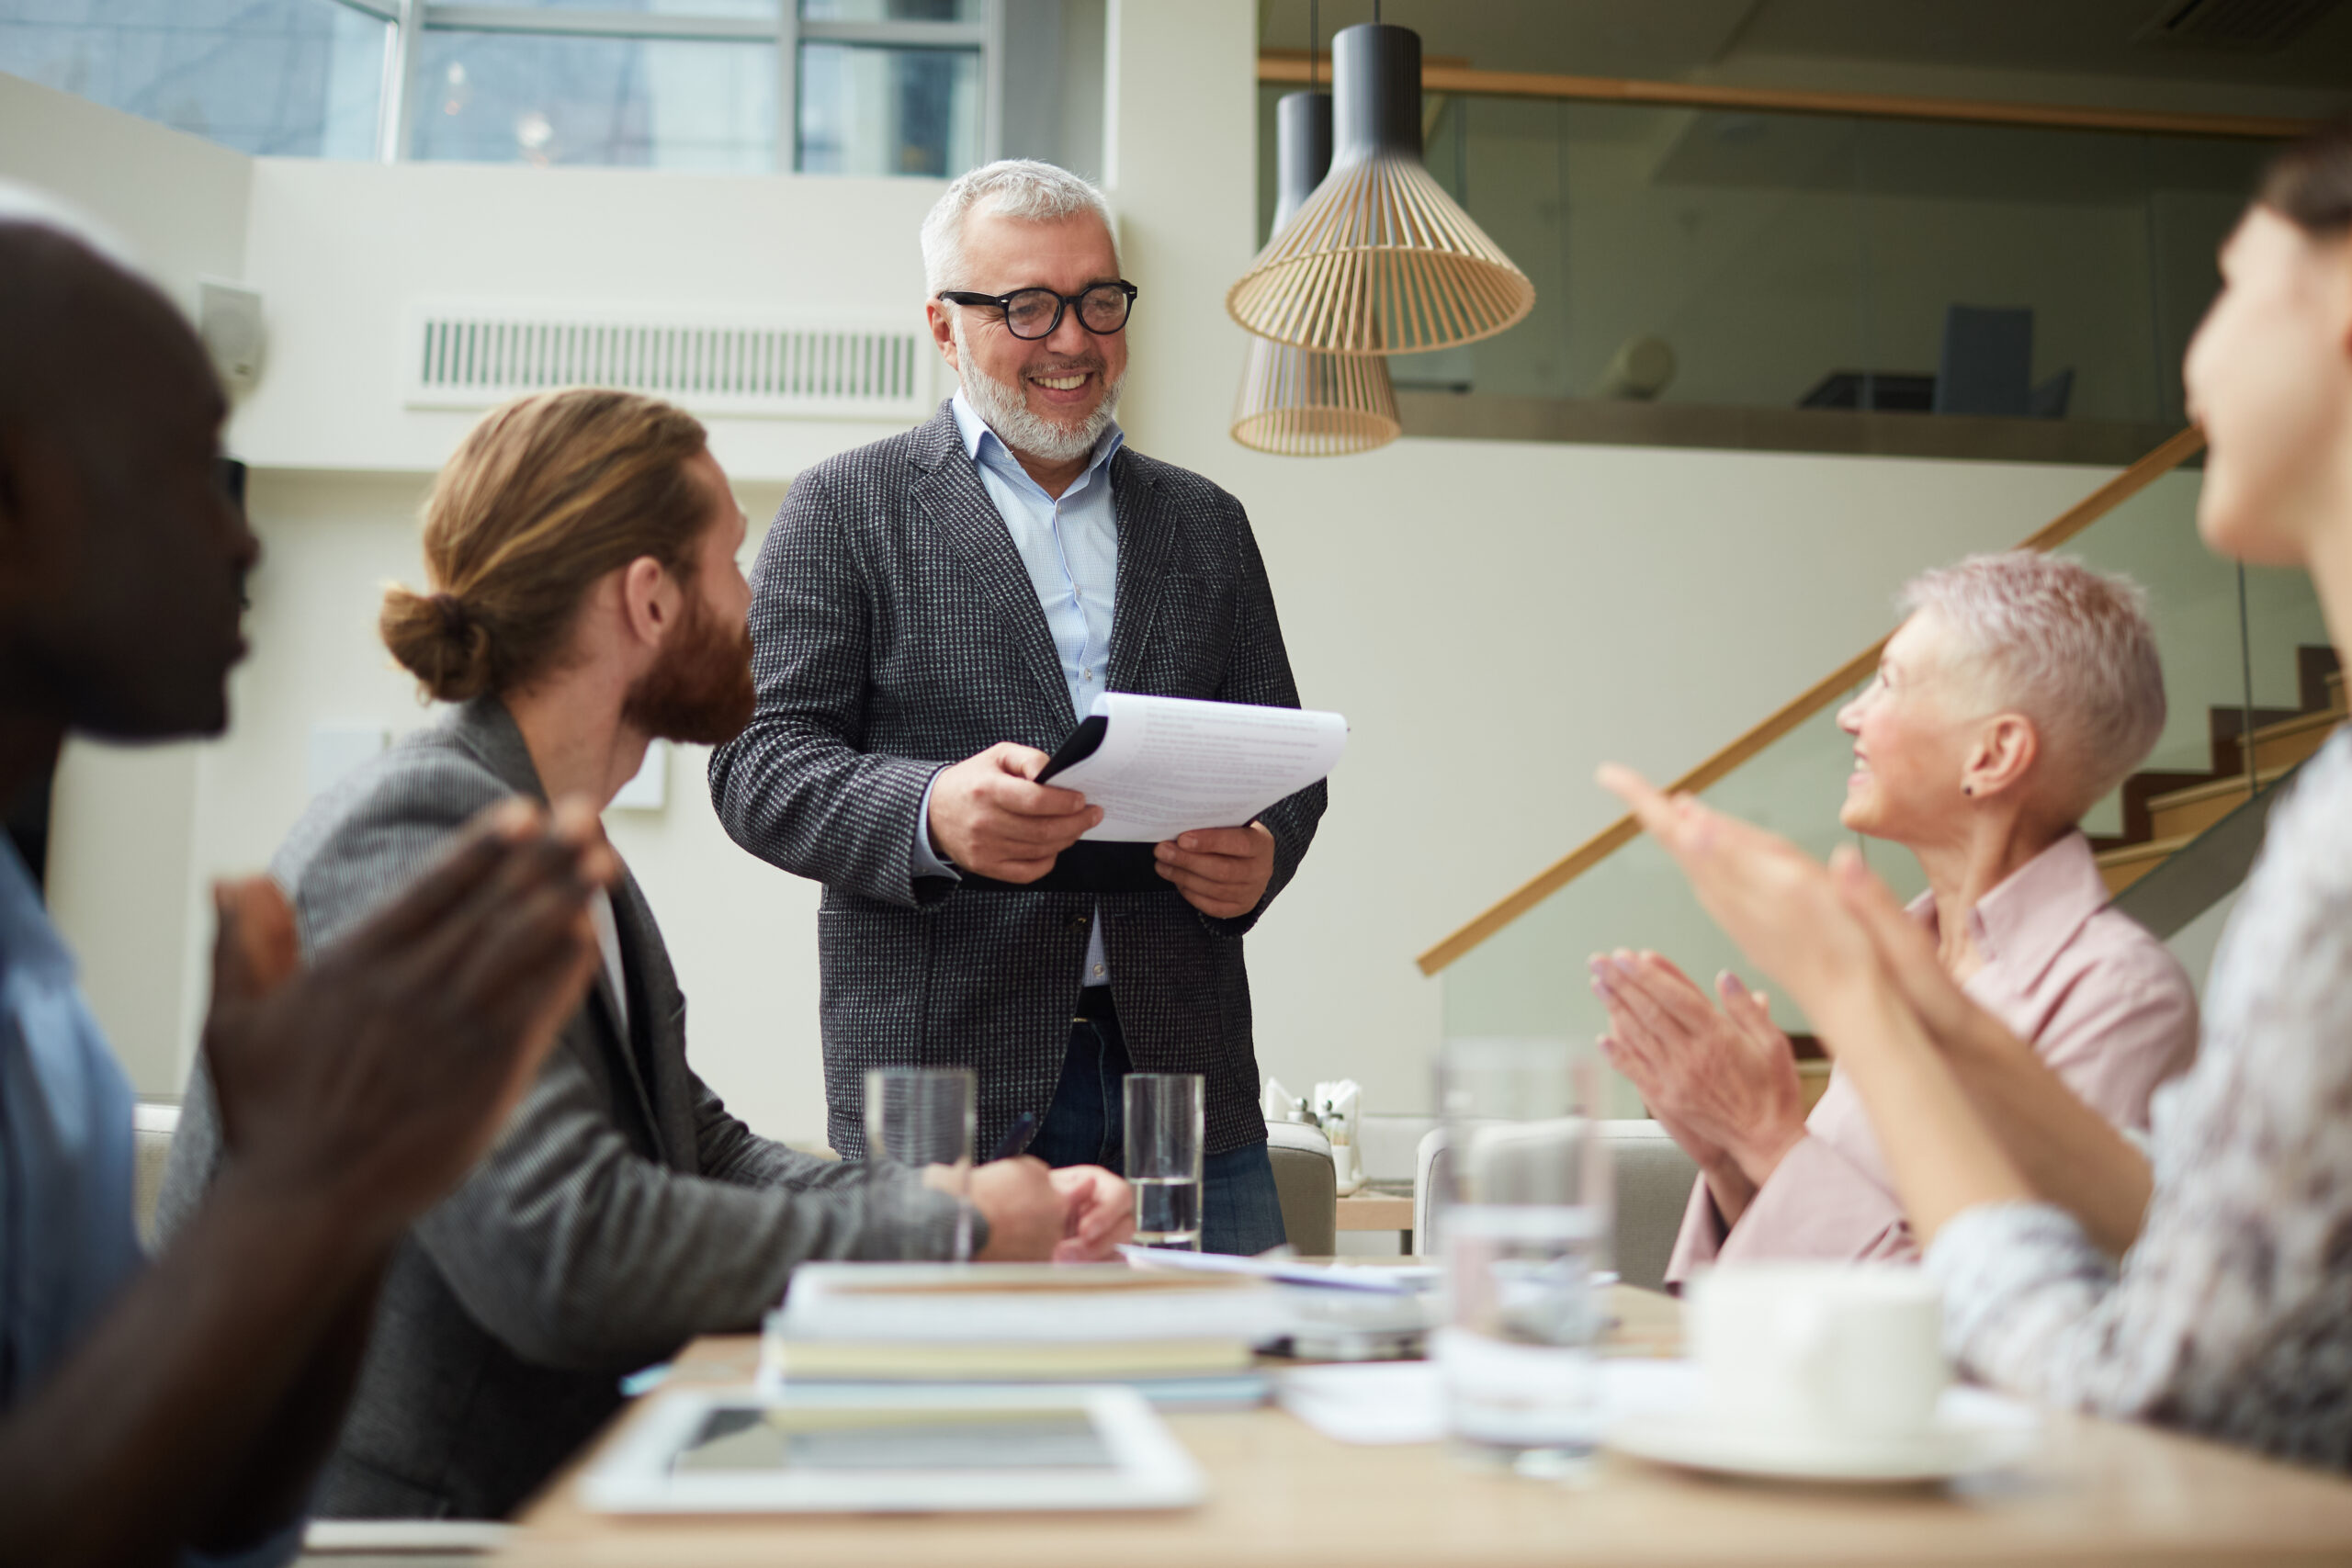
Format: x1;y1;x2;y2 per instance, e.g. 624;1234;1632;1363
231;157;945;479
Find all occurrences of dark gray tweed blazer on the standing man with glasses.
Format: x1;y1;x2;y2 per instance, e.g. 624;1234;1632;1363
710;404;1324;1156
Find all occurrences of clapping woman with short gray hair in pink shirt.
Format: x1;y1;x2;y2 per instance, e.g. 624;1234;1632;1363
1592;550;2197;1283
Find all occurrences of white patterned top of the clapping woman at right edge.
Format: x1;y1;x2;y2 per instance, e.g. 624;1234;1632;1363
1927;728;2352;1470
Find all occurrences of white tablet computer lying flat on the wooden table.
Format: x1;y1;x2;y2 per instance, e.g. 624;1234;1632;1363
579;1384;1202;1514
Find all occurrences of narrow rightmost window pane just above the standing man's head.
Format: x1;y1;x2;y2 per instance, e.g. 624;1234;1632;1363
799;42;981;176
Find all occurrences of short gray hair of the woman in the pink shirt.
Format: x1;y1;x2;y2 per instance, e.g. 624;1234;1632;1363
1900;550;2164;816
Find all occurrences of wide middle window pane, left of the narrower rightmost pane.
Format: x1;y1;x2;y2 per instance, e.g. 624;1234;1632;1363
412;28;776;172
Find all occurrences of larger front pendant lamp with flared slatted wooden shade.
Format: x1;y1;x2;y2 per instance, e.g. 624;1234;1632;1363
1226;21;1536;355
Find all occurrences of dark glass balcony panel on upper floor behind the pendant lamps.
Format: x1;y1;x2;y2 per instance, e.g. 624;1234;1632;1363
1261;87;2275;439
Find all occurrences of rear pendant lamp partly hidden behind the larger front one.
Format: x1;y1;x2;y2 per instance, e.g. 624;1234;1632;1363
1232;92;1404;458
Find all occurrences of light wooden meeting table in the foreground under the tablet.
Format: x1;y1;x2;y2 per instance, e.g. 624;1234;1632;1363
501;1286;2352;1568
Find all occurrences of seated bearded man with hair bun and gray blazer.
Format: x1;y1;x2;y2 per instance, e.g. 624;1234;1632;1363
160;388;1131;1518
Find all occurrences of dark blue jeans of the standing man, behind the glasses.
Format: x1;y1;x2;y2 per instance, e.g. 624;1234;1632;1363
1025;991;1282;1256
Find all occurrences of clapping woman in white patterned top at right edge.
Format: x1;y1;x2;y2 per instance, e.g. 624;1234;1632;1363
1604;120;2352;1470
